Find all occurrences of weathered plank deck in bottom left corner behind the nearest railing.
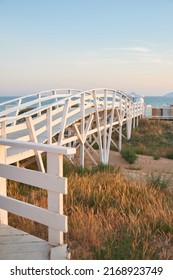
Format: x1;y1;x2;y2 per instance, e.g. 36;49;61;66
0;224;52;260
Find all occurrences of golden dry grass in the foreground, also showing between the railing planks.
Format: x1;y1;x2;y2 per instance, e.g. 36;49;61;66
8;166;173;259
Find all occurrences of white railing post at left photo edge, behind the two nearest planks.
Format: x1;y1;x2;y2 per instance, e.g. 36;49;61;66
0;146;8;225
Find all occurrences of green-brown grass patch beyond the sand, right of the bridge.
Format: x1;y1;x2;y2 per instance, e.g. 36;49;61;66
120;119;173;159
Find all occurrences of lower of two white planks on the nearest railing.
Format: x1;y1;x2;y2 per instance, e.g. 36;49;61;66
0;195;67;232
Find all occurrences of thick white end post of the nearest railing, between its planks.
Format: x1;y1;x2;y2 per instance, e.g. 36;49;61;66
47;153;63;246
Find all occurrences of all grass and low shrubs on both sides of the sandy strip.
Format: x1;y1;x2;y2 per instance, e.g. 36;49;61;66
8;120;173;260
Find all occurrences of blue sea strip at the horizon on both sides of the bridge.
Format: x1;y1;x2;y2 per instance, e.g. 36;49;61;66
0;96;173;108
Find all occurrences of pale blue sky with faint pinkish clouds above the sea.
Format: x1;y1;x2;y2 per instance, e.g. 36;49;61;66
0;0;173;96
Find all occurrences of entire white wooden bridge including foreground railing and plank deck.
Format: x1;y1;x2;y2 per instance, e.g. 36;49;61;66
0;89;145;259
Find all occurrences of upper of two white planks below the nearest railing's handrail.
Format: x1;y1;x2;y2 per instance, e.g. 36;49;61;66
0;163;67;194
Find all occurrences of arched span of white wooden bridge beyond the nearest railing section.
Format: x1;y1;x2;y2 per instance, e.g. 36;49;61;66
0;88;144;171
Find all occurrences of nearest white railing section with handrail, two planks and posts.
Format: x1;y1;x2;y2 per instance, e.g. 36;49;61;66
0;138;75;258
